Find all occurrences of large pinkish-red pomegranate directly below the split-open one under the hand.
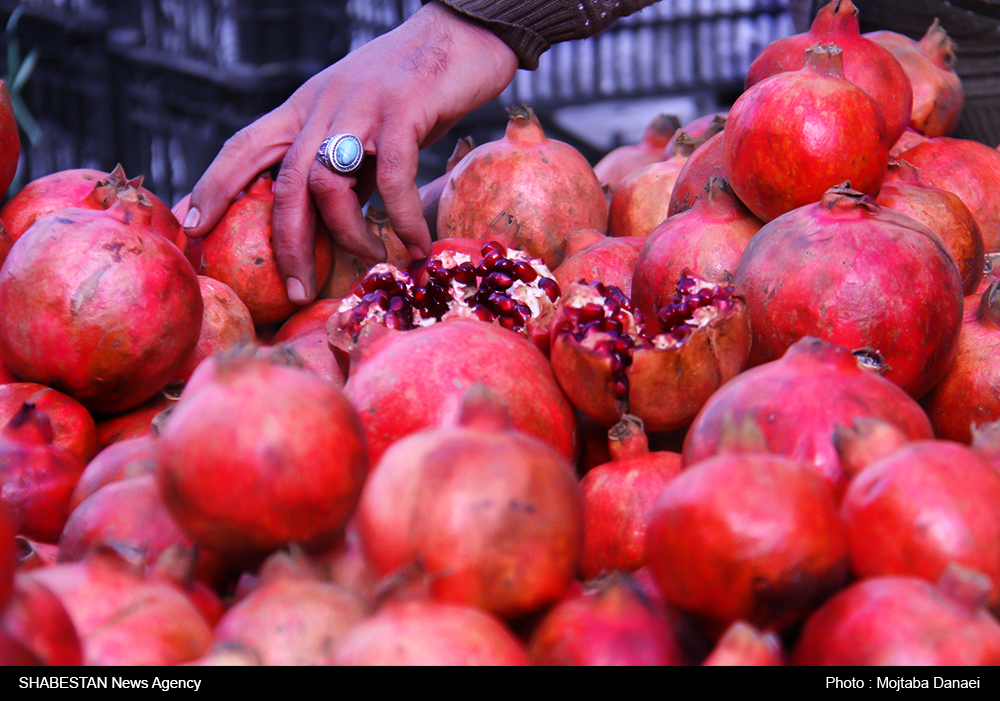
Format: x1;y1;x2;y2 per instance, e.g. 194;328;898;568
344;320;577;464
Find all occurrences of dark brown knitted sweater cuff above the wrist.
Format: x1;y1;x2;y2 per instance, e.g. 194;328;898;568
424;0;657;69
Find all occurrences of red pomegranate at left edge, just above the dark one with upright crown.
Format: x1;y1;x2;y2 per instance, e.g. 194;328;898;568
0;382;97;463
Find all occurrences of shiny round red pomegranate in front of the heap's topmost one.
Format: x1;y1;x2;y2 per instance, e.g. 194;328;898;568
723;45;888;221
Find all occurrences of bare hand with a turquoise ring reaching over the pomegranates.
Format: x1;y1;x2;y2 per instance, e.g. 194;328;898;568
184;2;518;303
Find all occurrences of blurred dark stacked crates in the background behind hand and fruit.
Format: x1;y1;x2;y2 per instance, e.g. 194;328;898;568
0;0;1000;204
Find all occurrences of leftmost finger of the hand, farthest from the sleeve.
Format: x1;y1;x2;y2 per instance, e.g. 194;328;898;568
182;108;298;237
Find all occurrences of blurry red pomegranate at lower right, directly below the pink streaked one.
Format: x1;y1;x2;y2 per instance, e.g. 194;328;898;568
646;453;847;633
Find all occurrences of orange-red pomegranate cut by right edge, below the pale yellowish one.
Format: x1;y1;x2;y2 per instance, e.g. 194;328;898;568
900;136;1000;253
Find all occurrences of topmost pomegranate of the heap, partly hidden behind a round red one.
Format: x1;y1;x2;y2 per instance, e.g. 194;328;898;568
746;0;913;144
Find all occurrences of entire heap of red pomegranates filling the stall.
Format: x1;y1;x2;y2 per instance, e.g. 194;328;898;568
0;0;1000;666
